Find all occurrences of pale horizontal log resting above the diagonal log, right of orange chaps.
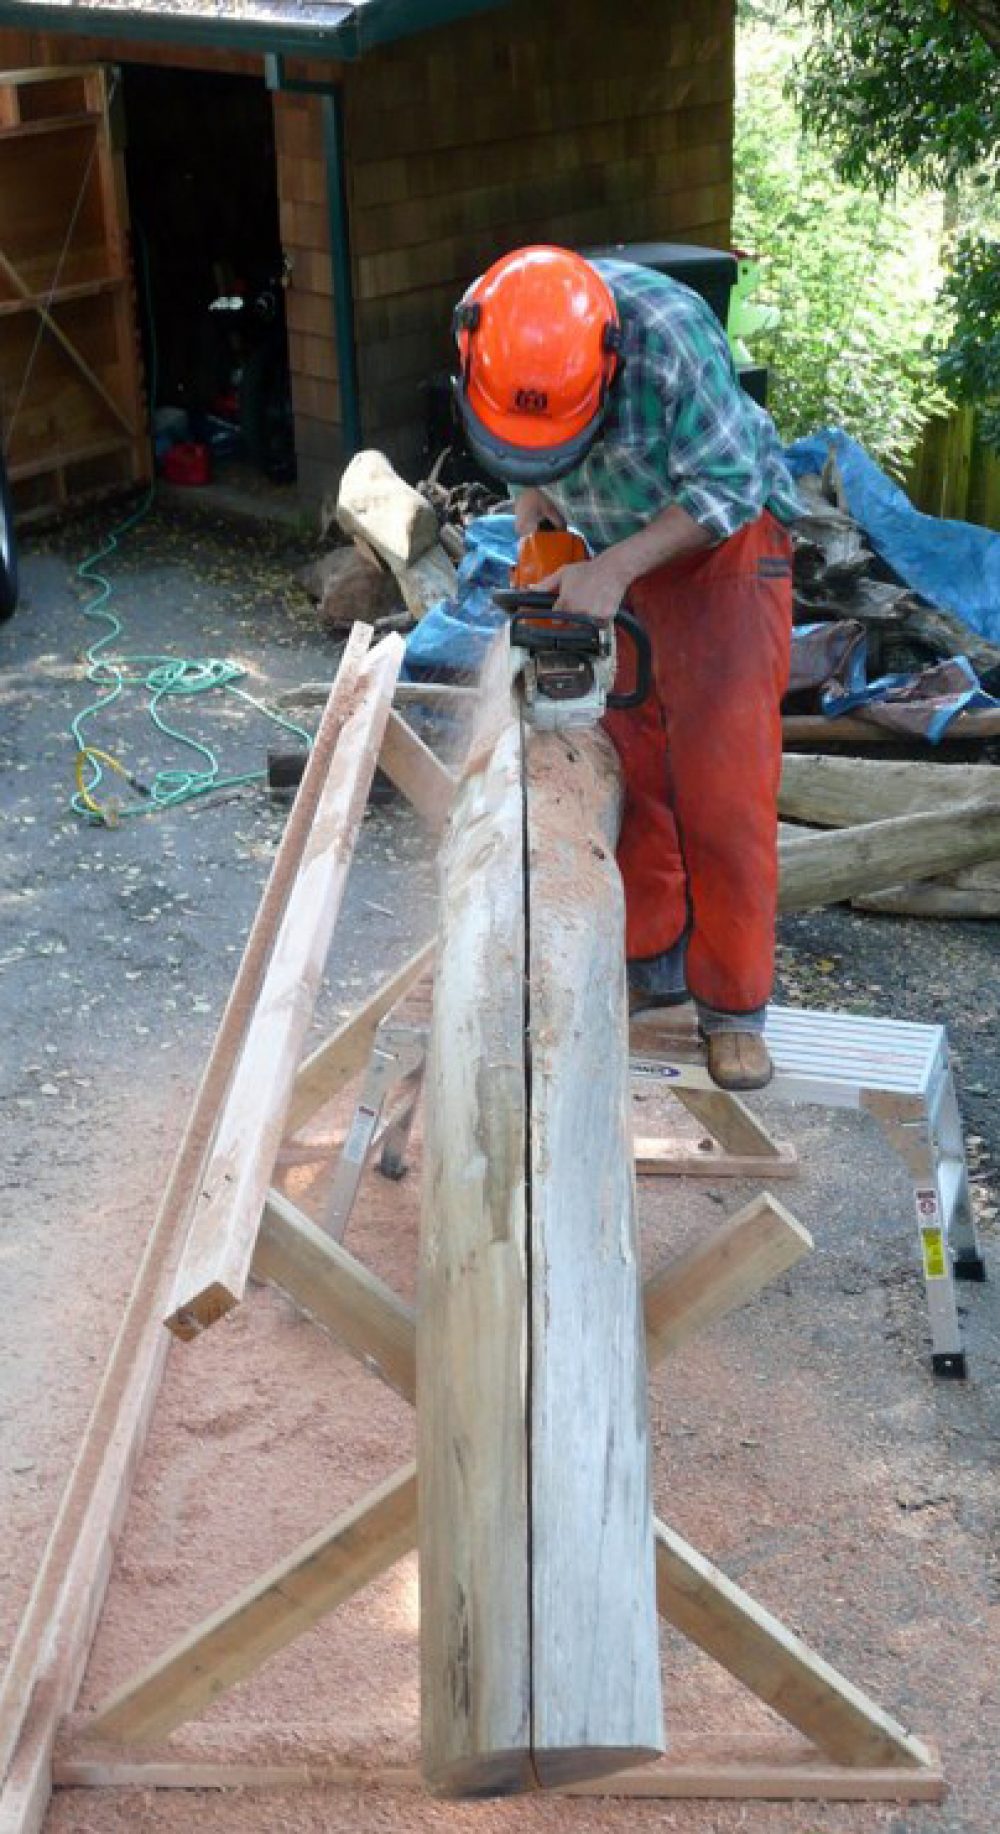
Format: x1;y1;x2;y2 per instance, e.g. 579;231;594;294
778;752;1000;827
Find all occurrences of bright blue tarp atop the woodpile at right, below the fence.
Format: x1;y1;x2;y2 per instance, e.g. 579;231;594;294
785;427;1000;644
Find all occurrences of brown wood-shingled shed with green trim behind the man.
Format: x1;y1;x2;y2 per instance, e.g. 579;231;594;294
0;0;734;508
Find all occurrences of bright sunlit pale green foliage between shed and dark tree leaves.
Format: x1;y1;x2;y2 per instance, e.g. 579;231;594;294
734;25;941;473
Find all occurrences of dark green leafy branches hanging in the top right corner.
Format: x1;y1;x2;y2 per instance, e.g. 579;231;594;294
793;0;1000;196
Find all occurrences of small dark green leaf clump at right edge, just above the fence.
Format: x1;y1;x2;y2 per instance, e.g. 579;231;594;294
938;235;1000;451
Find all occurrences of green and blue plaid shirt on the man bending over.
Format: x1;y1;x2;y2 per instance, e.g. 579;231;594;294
545;260;802;552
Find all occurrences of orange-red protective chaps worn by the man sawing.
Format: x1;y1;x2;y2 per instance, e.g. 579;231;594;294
606;512;791;1014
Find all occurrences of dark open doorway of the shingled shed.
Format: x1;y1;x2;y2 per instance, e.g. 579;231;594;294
123;64;295;490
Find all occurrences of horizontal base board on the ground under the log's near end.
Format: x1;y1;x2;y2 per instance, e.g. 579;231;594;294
55;1746;947;1803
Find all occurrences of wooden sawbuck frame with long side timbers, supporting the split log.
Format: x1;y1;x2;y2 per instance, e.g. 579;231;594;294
0;627;943;1834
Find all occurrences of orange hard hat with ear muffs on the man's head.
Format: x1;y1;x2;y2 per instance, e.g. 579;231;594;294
453;248;622;484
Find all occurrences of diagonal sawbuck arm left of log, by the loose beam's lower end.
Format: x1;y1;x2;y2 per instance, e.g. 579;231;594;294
253;1190;417;1401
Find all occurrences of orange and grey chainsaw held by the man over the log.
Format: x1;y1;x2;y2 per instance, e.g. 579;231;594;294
494;523;653;732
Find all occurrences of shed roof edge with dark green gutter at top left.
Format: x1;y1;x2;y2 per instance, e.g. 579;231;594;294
0;0;506;61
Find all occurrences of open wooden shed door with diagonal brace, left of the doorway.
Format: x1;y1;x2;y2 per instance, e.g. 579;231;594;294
0;66;150;523
